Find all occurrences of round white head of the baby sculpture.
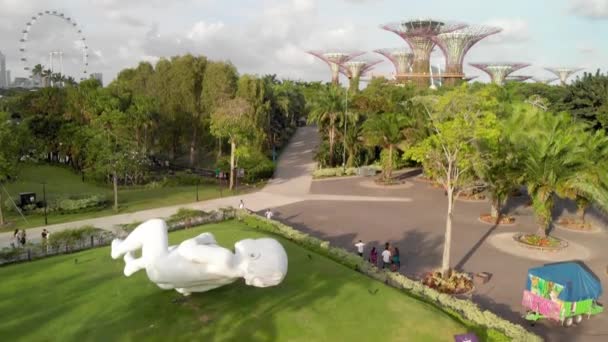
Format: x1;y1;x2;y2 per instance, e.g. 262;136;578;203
234;238;287;287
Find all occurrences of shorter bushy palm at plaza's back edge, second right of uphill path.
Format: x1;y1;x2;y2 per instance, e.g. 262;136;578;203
363;112;411;182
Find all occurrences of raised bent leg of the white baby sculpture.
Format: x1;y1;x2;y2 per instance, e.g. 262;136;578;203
112;219;168;259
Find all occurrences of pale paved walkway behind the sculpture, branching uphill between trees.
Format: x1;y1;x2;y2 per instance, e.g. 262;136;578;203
0;126;409;247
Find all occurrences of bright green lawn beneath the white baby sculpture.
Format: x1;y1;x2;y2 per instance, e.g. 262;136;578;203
0;221;506;342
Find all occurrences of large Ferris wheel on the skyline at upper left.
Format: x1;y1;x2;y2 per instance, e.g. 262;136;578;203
19;10;89;80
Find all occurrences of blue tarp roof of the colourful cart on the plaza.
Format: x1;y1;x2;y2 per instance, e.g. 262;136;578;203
526;262;602;302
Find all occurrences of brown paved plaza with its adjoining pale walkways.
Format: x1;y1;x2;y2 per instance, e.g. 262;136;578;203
0;127;608;341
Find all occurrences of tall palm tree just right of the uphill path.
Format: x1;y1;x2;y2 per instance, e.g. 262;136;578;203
308;86;345;166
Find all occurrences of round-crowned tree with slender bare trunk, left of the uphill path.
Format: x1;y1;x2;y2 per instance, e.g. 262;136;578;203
211;97;254;190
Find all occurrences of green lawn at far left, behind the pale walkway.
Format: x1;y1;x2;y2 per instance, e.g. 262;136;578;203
0;164;252;231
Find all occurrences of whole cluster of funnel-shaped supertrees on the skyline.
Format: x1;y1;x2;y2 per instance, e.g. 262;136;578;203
308;19;581;88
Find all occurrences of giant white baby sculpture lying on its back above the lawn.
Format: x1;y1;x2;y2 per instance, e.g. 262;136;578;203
112;219;287;296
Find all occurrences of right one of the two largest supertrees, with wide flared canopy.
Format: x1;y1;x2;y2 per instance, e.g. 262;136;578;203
430;25;502;84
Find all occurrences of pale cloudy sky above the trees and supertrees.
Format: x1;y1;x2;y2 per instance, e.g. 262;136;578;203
0;0;608;84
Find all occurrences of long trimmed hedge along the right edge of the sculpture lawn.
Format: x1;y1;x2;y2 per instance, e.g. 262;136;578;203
237;210;542;342
